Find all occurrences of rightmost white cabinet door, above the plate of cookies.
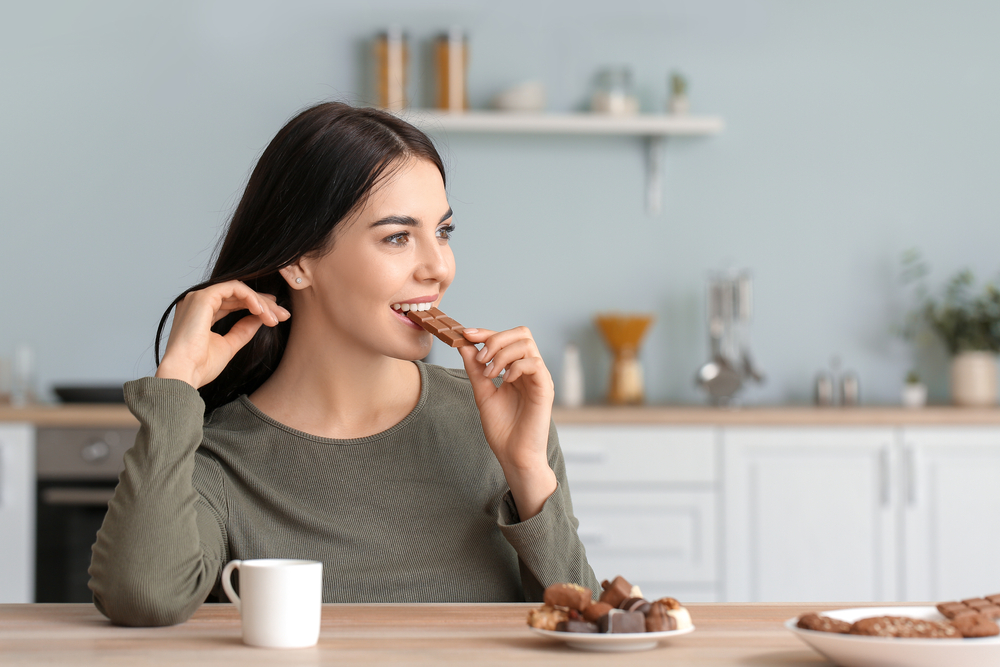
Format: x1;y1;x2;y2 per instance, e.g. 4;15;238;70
902;427;1000;602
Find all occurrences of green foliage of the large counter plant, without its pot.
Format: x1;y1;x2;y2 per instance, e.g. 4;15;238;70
903;250;1000;354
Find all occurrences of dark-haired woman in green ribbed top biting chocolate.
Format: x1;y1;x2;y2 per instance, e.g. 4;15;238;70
90;103;598;625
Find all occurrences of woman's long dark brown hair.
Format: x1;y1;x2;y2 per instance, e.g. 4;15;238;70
154;102;444;413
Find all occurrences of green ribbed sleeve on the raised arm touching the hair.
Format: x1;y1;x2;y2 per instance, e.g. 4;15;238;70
89;378;227;626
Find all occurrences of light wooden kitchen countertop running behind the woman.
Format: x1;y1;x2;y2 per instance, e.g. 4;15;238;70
0;404;1000;428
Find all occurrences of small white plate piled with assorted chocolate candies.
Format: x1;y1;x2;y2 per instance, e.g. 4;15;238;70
528;576;694;651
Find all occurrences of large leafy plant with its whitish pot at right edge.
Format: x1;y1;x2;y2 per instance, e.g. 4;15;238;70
904;252;1000;406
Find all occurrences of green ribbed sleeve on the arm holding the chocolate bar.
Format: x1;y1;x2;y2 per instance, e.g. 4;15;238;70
497;425;601;602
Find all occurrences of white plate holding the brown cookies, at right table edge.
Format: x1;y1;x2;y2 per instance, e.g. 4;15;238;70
785;607;1000;667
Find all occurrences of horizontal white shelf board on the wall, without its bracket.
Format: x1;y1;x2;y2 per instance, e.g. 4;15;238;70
401;110;724;137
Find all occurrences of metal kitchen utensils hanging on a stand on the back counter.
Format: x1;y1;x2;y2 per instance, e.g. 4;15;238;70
695;271;764;405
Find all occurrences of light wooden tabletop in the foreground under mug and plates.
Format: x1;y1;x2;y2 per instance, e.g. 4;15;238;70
0;602;920;667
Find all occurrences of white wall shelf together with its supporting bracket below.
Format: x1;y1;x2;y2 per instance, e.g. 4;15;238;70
401;110;725;214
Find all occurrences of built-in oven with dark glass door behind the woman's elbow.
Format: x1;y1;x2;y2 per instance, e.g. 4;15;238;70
35;427;138;602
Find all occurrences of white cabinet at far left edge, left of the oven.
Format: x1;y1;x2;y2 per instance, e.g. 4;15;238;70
0;424;35;603
